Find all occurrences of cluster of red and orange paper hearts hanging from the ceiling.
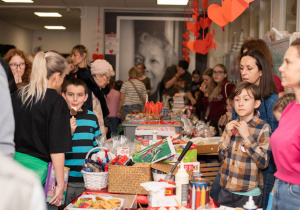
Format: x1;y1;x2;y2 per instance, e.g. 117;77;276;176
186;0;254;55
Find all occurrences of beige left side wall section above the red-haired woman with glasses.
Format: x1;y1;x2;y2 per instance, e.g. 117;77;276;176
0;20;33;53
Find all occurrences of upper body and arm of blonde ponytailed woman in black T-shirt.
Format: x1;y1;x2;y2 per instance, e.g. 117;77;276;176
12;52;72;206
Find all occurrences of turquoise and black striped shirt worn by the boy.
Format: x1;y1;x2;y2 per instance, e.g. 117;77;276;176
65;109;101;182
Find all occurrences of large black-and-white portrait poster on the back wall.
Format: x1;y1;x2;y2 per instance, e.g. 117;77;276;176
116;16;196;101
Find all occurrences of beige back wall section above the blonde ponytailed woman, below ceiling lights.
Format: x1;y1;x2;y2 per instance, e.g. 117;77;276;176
31;31;80;53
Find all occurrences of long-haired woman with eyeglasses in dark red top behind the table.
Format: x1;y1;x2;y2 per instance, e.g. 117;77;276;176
202;64;235;136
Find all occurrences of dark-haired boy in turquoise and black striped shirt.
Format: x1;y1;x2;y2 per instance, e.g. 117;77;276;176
62;78;101;205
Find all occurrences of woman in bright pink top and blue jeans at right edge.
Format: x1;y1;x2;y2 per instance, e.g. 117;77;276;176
271;39;300;210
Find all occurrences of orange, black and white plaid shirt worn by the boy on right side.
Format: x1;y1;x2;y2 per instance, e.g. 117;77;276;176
219;116;271;192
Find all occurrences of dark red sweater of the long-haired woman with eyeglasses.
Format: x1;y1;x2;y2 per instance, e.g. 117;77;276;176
202;80;235;121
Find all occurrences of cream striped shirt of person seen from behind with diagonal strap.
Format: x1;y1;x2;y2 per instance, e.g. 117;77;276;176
120;79;146;105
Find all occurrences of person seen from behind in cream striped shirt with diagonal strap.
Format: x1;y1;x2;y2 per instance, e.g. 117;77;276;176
117;67;146;122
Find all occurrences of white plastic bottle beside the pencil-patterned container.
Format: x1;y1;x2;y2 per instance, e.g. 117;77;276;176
175;161;189;206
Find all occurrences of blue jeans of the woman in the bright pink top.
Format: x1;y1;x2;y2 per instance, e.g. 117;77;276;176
272;179;300;210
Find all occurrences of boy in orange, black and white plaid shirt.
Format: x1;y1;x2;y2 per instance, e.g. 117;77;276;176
218;82;271;207
